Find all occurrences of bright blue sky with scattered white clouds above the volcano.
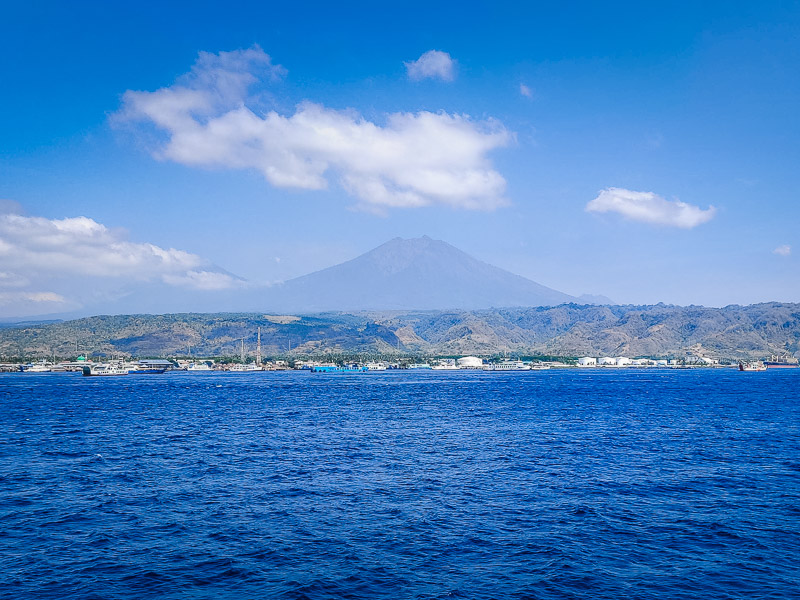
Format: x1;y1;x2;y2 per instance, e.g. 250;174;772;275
0;0;800;317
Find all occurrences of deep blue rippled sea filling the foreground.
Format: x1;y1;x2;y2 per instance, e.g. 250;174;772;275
0;369;800;599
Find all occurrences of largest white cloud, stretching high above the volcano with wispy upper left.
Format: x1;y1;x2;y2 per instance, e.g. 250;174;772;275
117;48;513;209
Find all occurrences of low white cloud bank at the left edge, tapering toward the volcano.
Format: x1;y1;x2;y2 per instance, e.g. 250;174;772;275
0;214;241;290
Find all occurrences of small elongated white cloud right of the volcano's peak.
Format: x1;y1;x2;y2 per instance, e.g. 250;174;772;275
586;188;716;229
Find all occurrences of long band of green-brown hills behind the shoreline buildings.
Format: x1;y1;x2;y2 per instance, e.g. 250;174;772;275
0;303;800;360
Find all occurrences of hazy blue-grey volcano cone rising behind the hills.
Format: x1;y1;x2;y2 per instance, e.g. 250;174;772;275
264;236;577;312
